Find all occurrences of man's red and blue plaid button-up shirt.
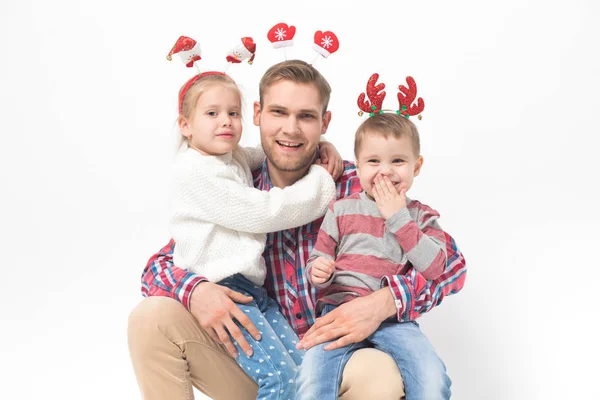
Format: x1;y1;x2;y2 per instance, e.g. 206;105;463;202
142;161;466;337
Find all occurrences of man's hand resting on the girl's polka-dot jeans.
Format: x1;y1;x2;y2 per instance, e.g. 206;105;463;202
190;282;260;357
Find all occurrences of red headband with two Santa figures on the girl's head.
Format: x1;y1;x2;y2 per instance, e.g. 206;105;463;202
167;36;256;114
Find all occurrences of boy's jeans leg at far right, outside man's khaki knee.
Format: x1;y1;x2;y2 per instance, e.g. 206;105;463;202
368;321;452;400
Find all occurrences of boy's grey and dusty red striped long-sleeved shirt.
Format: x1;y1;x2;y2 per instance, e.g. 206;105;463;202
307;192;460;314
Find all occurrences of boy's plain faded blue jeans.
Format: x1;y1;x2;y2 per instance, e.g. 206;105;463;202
296;305;451;400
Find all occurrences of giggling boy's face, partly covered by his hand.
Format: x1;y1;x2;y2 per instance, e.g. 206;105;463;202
356;131;423;197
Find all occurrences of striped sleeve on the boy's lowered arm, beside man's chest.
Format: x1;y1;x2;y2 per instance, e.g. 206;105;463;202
305;202;339;289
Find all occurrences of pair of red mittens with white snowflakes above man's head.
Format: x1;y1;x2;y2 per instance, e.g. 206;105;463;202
267;22;340;64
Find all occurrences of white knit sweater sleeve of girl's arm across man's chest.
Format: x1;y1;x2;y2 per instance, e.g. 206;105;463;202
173;165;336;233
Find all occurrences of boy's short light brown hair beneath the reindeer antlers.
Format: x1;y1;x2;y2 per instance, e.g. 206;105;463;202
354;113;421;160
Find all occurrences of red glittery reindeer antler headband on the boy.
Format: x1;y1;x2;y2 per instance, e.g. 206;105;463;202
357;73;425;119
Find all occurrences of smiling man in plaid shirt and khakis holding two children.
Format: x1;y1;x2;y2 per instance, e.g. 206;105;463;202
128;60;465;400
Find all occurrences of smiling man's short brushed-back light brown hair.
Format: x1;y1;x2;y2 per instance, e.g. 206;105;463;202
258;60;331;114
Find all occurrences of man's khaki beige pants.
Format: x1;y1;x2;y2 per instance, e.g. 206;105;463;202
128;297;404;400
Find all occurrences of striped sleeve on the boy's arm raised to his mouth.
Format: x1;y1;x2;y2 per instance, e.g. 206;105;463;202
385;202;446;279
